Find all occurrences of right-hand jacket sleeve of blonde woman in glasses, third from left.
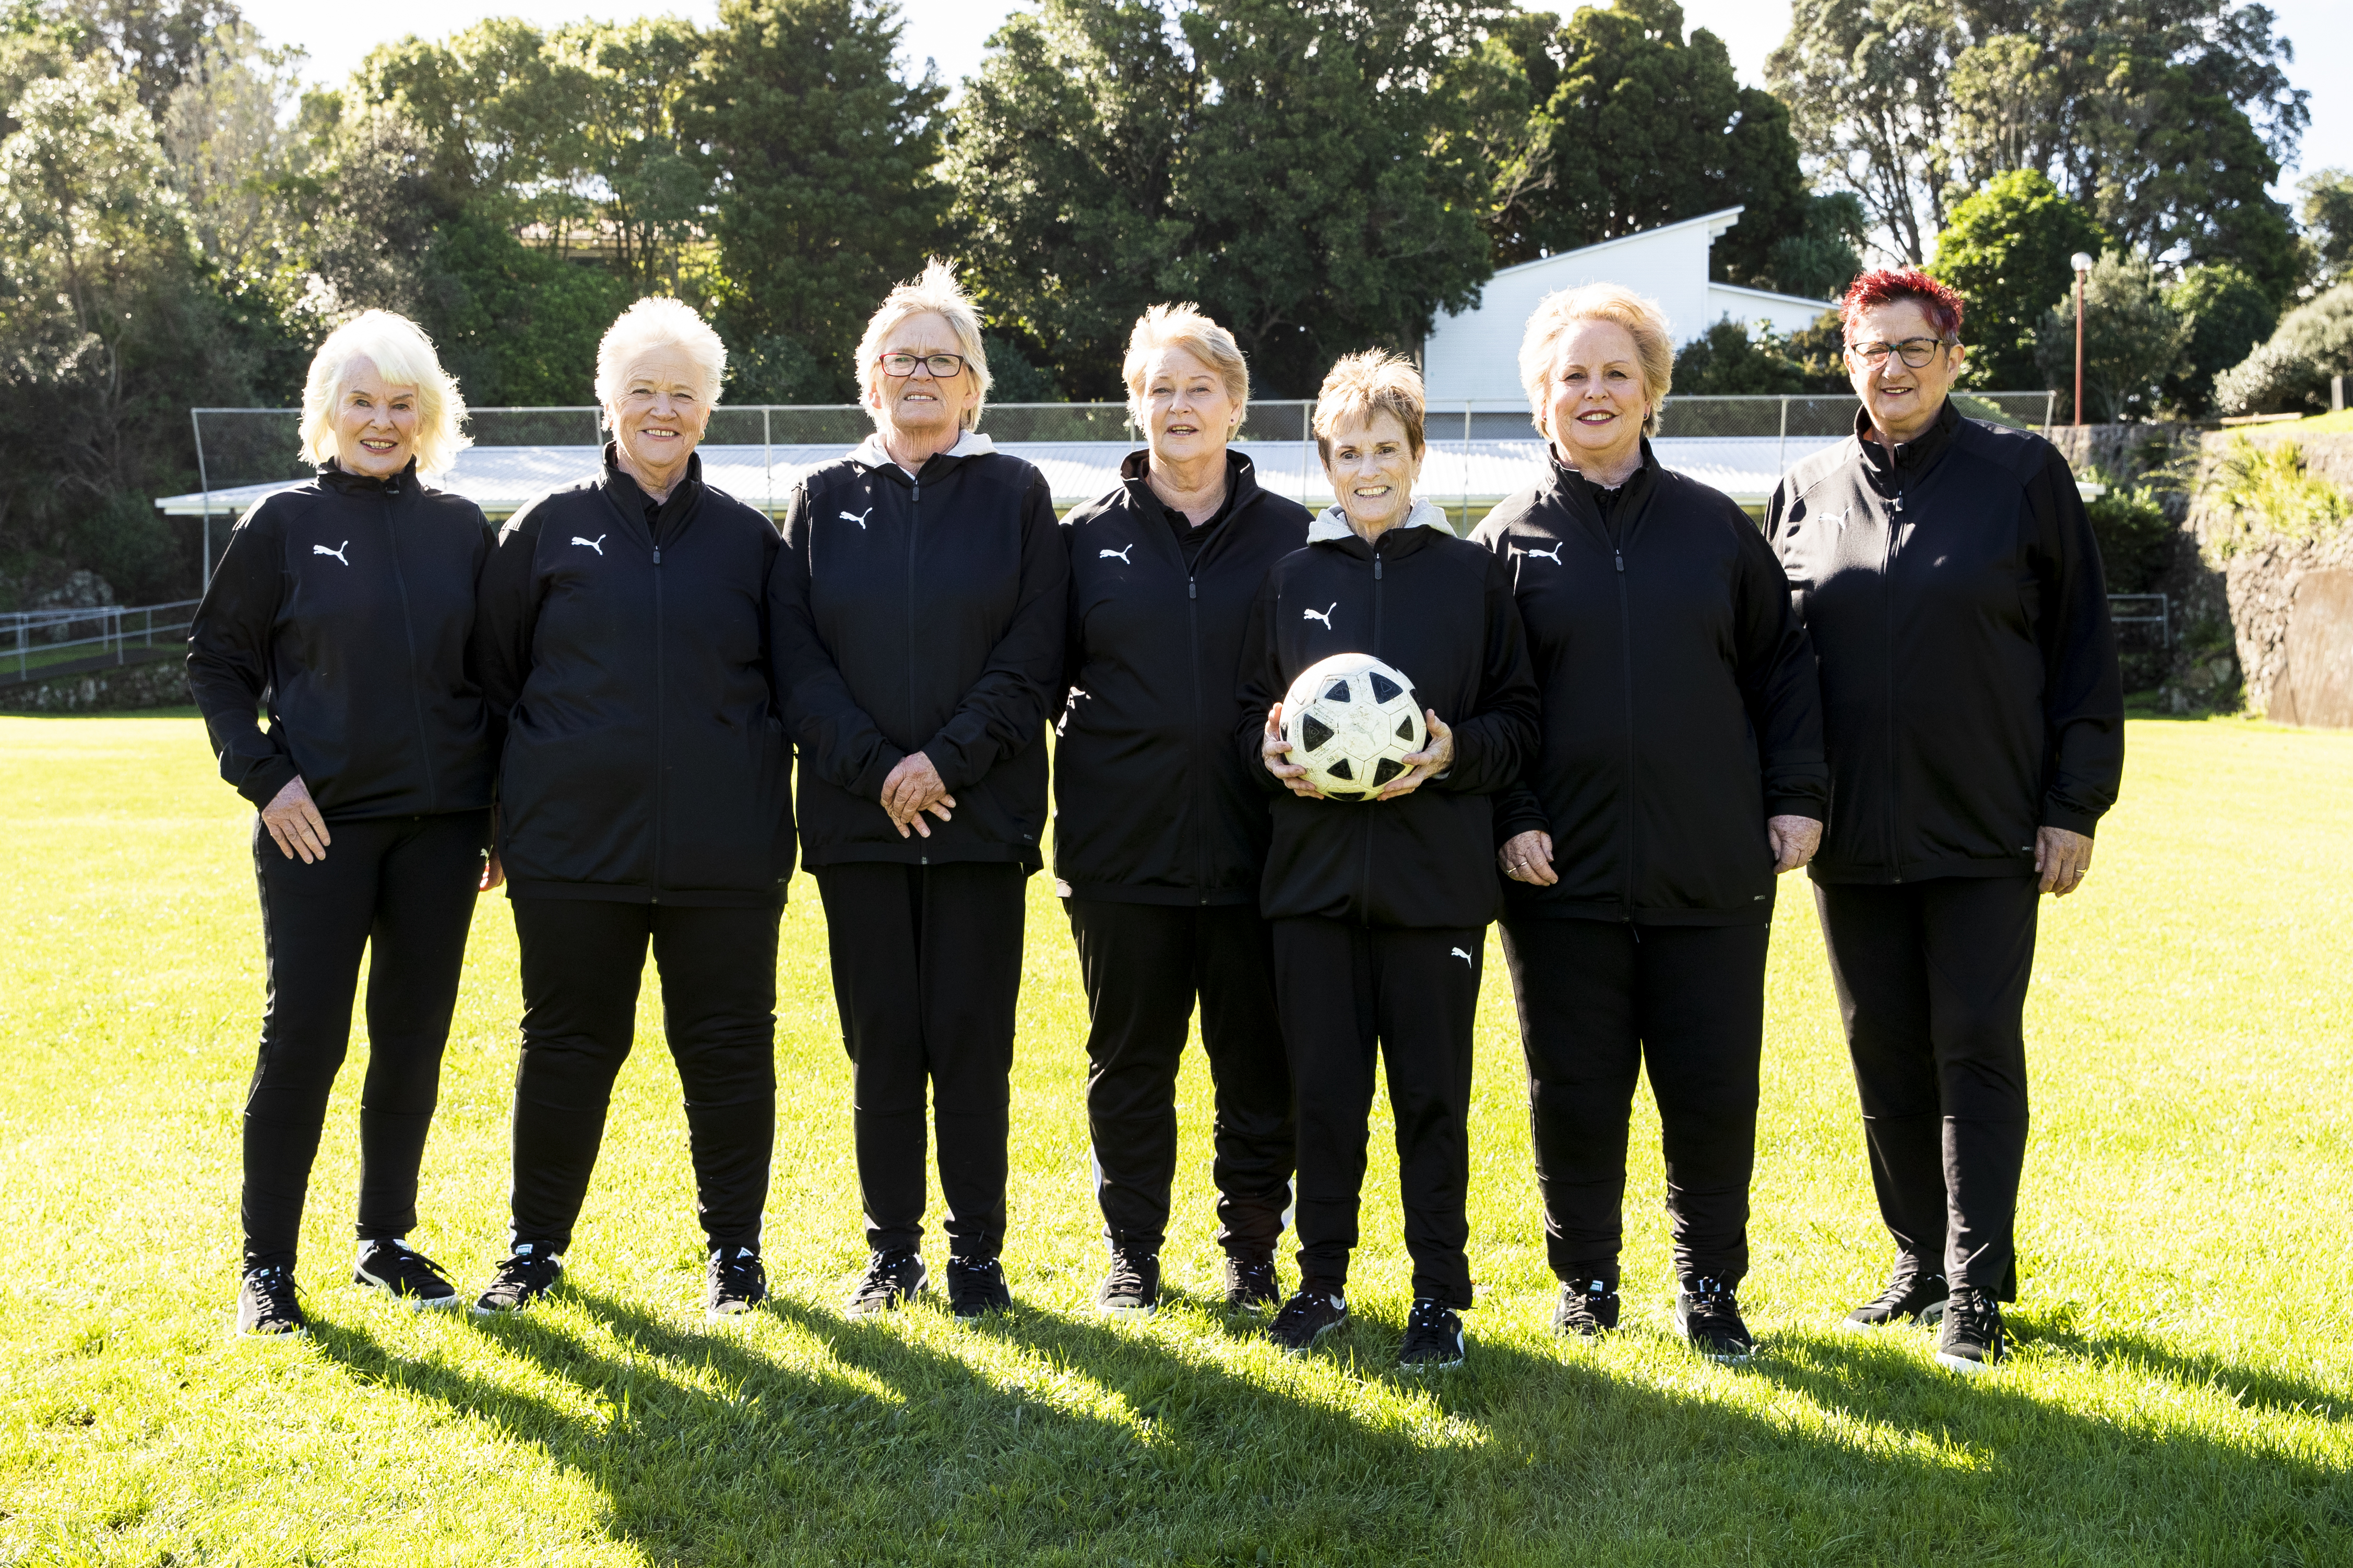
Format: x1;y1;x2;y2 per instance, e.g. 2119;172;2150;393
922;475;1071;790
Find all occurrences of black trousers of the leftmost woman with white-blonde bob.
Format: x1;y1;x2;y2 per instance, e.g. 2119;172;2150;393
242;811;490;1270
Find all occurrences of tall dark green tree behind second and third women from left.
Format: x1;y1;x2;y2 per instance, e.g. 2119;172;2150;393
682;0;948;402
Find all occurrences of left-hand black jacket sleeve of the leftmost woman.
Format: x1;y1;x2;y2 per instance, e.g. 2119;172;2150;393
188;498;296;806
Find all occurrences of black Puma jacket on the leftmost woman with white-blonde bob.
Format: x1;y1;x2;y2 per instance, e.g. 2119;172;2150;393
188;463;492;823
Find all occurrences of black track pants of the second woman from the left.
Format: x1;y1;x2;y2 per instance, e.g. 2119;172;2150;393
513;898;783;1253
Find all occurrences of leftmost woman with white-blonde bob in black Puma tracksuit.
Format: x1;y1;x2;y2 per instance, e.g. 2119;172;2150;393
188;310;499;1335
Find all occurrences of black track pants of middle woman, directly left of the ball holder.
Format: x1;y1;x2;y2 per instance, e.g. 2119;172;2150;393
1064;898;1292;1258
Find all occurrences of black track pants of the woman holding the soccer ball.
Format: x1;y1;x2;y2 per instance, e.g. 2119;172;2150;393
1273;919;1485;1307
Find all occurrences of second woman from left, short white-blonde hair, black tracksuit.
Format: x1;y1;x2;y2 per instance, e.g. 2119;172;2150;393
476;298;793;1316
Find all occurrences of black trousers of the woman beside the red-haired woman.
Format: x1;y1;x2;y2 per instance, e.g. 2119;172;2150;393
1504;919;1772;1290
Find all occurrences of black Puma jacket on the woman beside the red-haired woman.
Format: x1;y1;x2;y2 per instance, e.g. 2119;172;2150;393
1471;439;1831;926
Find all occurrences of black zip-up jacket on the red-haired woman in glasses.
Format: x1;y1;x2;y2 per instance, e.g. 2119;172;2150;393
1765;402;2125;884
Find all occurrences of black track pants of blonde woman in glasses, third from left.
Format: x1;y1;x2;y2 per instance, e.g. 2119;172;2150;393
814;860;1024;1260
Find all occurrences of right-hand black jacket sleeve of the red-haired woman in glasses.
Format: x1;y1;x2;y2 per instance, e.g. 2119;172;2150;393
2026;447;2125;834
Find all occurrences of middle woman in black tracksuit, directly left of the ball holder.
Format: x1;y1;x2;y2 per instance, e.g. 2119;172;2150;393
1054;306;1308;1314
